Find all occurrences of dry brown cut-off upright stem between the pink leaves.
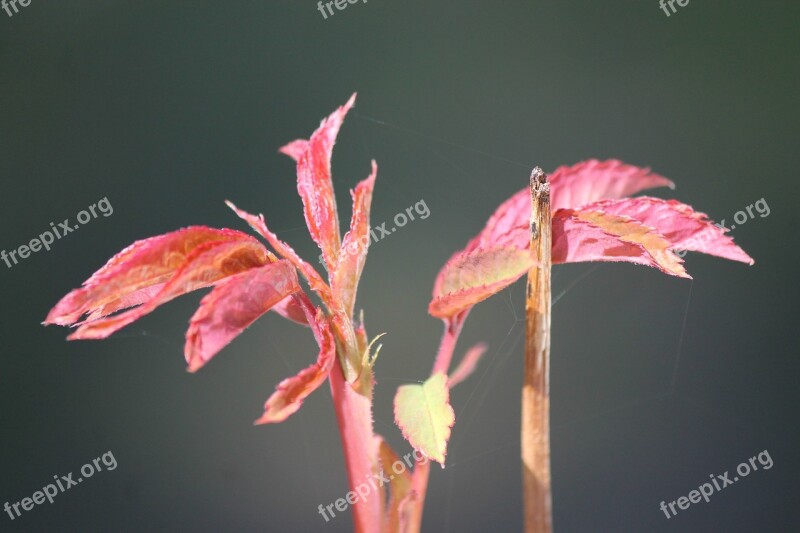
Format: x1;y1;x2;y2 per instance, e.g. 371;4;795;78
521;167;553;533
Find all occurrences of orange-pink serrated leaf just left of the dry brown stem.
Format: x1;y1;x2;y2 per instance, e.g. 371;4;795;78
428;248;534;318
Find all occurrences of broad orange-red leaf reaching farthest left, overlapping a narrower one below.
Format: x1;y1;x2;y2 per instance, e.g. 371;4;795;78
44;226;271;326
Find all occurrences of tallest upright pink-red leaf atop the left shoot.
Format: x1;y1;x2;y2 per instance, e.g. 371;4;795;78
289;94;356;271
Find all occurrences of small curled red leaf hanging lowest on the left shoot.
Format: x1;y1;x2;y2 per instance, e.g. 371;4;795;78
255;312;336;424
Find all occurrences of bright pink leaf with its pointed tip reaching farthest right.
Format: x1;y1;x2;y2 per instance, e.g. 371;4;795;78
584;196;753;265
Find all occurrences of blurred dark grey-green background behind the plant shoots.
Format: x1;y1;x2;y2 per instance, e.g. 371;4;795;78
0;0;800;532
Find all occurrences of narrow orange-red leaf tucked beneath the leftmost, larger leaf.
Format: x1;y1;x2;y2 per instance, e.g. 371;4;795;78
63;238;270;340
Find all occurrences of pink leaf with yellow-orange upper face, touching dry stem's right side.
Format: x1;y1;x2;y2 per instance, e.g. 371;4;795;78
552;209;690;278
